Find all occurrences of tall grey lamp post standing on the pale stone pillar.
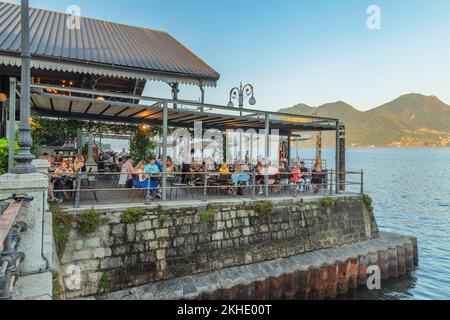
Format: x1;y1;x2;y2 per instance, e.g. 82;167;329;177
10;0;36;174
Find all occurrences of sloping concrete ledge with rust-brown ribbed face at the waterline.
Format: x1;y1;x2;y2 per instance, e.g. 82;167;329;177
98;233;418;300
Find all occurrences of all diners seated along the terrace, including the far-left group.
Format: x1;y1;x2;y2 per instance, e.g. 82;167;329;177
42;149;326;203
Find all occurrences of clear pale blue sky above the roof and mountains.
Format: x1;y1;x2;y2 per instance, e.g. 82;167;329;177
7;0;450;110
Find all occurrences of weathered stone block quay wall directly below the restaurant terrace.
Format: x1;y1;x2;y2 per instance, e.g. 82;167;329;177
60;196;379;298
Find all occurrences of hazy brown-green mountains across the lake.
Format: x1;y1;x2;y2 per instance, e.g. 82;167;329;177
280;94;450;147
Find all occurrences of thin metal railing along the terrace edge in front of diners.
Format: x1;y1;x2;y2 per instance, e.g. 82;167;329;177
49;170;364;208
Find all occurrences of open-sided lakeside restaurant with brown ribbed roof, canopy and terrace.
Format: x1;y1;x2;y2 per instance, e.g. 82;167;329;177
0;2;352;207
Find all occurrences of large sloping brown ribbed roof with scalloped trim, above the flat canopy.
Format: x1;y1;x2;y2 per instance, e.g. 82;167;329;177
0;1;220;85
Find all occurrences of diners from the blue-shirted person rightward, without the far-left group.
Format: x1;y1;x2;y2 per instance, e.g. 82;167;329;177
118;156;327;198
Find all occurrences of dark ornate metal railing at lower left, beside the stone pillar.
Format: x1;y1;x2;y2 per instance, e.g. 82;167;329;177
0;194;33;300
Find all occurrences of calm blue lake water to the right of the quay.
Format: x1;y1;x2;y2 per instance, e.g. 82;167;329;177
296;148;450;299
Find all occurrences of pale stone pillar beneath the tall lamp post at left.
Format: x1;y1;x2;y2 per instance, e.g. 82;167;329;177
0;173;49;273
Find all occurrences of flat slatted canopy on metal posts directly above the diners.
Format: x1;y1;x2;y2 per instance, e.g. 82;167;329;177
27;85;337;135
